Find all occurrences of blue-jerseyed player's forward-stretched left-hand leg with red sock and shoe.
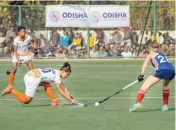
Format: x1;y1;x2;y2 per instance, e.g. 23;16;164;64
129;75;160;112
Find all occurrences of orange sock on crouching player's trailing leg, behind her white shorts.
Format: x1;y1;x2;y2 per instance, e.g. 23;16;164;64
11;89;27;104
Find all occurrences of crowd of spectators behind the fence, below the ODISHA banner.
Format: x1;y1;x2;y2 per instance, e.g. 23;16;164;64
0;24;175;58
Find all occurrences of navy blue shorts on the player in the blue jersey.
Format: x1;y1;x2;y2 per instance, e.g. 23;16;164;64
152;70;175;80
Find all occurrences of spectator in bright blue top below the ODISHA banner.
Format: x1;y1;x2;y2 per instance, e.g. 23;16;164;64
60;30;70;47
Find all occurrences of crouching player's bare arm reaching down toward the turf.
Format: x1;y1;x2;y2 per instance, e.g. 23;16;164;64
56;83;76;103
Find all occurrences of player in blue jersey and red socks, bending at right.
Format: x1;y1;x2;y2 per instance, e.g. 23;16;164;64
129;41;175;112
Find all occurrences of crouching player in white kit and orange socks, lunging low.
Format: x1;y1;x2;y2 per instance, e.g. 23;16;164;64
2;62;84;107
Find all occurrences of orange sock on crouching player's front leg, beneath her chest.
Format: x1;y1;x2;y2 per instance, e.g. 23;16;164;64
44;84;58;103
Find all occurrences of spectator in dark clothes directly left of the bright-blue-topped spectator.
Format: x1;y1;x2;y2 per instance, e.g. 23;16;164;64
50;31;60;46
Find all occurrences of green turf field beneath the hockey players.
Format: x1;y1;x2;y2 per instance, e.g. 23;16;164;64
0;60;175;130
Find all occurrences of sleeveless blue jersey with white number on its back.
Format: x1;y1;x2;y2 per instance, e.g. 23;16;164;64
151;52;175;71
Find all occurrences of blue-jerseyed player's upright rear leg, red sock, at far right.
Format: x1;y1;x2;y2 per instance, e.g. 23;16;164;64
161;80;170;111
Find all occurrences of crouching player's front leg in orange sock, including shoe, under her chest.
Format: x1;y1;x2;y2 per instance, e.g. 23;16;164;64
43;83;62;107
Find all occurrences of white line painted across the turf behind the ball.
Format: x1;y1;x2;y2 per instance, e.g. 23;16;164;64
0;96;176;101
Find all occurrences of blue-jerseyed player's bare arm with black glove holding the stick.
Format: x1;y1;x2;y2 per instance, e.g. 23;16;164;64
138;55;151;82
